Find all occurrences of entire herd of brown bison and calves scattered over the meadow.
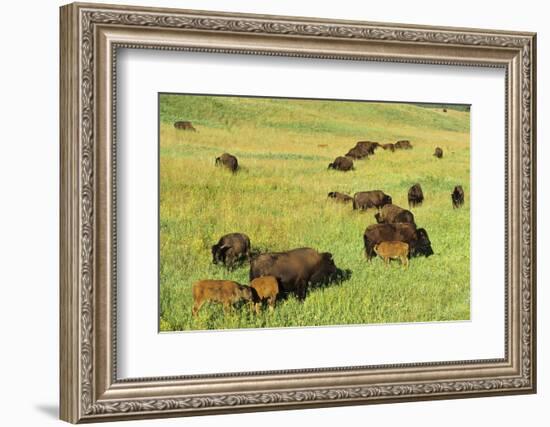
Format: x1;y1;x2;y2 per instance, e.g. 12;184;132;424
179;121;464;316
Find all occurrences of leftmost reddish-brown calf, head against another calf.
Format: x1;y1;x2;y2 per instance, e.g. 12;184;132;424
192;280;254;316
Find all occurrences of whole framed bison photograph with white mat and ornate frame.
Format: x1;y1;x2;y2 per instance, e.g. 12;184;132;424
60;4;536;423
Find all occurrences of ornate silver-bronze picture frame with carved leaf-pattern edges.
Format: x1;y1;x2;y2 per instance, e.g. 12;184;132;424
60;3;537;423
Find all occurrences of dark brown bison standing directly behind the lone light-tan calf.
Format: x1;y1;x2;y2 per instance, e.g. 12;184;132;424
363;223;433;260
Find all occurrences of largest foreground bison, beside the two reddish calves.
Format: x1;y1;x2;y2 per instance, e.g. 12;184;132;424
250;248;338;300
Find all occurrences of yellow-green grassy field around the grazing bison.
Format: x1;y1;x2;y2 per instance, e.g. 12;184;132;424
160;95;470;331
